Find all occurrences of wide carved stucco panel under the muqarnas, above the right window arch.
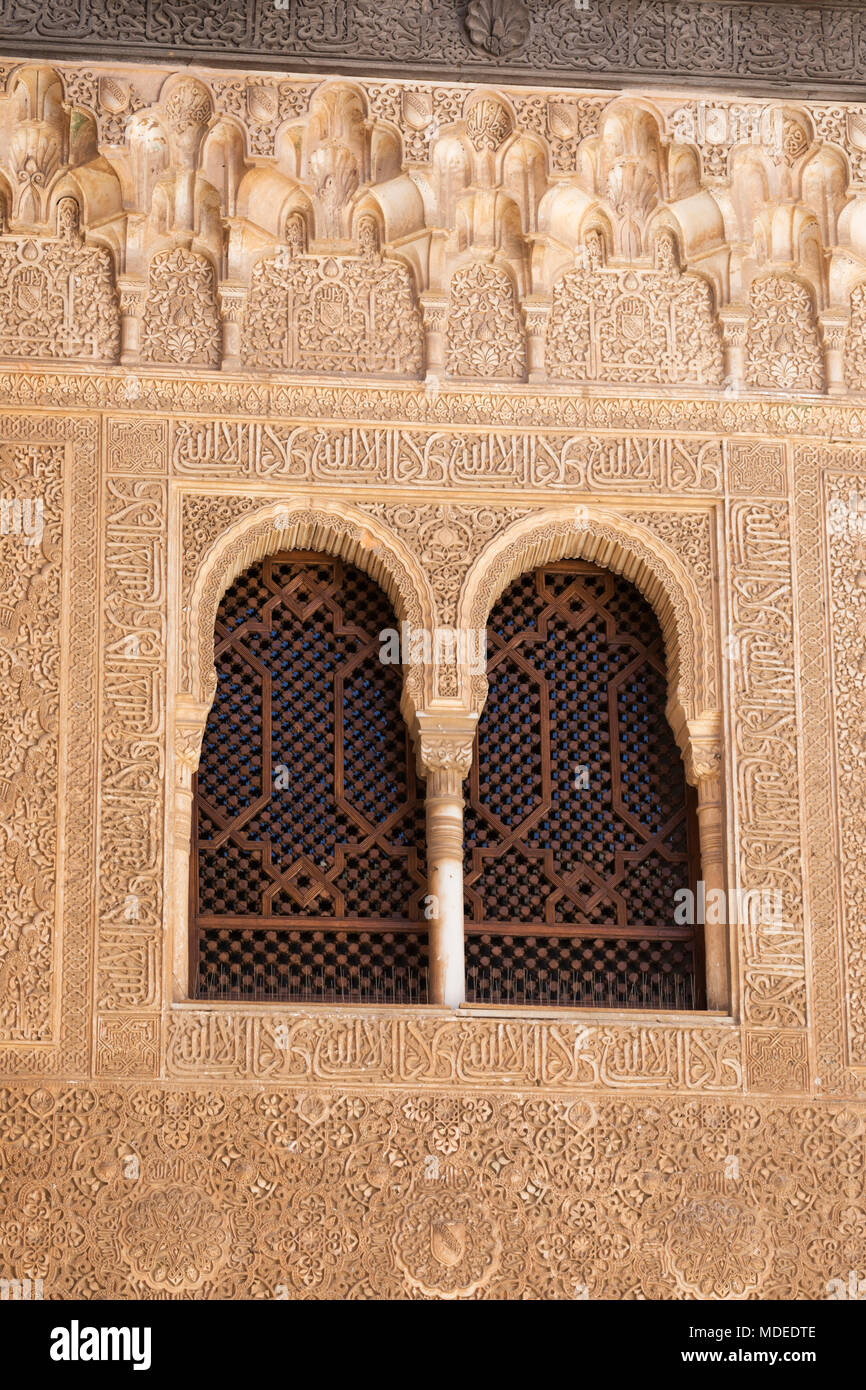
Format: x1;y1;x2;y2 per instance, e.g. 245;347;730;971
546;231;723;385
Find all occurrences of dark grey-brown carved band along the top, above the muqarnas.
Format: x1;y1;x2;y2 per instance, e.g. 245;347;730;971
8;0;866;96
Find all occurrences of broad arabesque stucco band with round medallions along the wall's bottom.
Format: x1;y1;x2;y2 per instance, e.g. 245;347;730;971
6;1083;866;1301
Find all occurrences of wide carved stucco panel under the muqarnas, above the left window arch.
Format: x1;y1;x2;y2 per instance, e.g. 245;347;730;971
243;214;424;377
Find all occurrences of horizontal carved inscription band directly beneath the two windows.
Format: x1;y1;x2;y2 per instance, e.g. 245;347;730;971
167;1011;742;1093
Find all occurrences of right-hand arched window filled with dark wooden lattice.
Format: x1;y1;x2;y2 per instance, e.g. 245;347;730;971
464;560;702;1008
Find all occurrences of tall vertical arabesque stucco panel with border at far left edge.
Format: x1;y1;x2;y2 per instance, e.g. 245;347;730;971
0;416;100;1076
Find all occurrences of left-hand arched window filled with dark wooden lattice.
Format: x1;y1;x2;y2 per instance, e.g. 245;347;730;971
190;552;427;1004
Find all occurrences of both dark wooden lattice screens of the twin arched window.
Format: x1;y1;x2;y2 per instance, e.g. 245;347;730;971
190;552;702;1008
